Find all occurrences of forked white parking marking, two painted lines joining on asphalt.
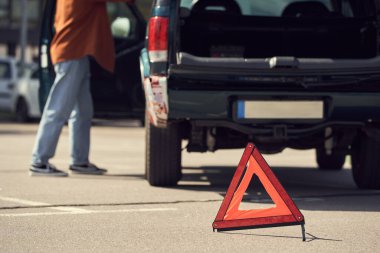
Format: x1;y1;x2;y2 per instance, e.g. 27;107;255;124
0;196;178;217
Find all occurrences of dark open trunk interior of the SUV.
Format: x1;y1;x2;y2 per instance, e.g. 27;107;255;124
179;12;378;59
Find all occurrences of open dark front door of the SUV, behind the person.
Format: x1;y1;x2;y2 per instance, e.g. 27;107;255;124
39;0;146;121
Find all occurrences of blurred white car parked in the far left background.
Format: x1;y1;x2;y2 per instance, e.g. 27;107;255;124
0;57;41;122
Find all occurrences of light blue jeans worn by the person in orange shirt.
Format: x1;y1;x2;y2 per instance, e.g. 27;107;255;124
32;57;93;164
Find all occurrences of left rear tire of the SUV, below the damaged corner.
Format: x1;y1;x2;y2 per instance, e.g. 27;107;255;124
145;113;182;186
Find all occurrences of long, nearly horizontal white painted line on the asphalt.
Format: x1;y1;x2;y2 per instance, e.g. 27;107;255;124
0;208;178;217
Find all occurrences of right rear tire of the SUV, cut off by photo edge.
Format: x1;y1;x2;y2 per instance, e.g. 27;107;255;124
351;132;380;189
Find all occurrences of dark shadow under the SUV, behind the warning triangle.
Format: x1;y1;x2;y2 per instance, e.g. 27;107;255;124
176;166;380;212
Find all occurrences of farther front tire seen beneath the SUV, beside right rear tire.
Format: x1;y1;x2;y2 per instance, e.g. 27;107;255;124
316;148;346;170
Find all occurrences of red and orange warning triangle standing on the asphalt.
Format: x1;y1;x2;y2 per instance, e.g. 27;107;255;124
212;143;305;240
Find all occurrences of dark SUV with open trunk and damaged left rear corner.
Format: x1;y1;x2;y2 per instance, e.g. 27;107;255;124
140;0;380;189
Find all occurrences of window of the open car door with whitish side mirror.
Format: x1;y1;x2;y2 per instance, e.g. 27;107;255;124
107;2;137;39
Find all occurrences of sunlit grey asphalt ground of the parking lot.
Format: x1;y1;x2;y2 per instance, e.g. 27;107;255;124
0;121;380;252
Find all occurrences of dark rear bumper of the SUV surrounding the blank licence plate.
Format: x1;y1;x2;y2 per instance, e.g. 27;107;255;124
168;90;380;125
